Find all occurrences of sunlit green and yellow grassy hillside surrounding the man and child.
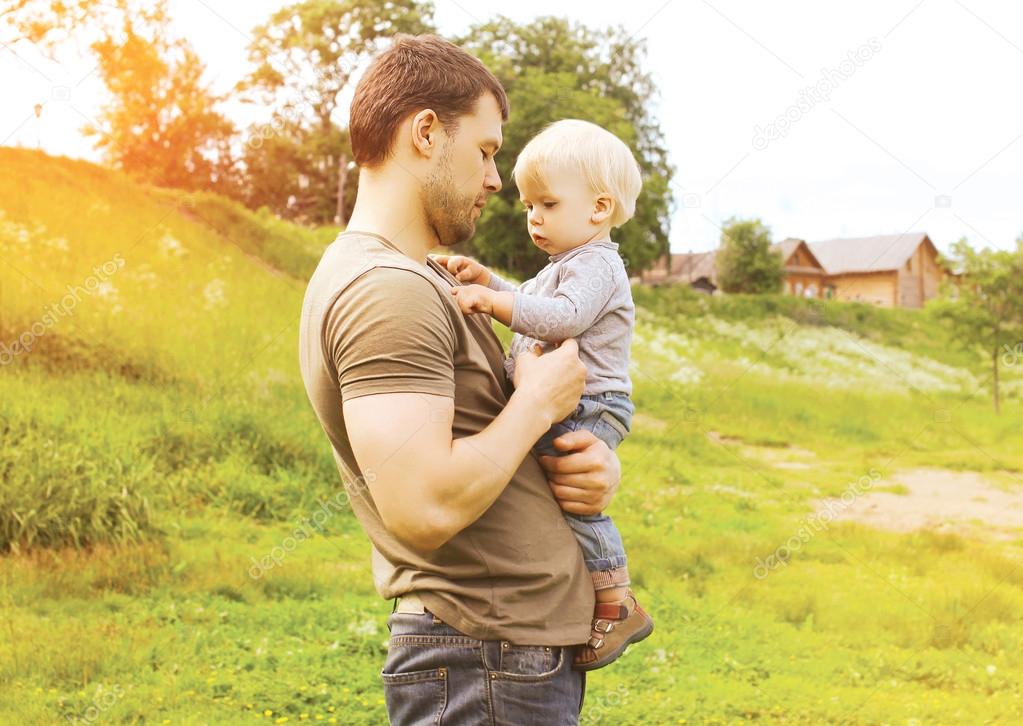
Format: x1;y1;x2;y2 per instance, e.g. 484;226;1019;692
0;148;1023;724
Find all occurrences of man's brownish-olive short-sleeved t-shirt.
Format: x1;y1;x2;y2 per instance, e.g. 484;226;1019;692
300;232;593;645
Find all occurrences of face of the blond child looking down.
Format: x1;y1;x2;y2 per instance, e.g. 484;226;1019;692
519;166;608;255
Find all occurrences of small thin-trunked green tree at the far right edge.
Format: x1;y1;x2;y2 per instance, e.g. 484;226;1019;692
927;237;1023;413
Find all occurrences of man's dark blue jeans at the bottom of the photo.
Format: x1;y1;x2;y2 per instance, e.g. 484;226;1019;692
381;610;586;726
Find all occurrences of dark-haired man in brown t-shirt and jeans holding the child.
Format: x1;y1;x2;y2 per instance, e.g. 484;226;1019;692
301;36;620;725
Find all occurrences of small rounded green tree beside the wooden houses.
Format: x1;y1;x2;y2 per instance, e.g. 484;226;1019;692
716;217;784;293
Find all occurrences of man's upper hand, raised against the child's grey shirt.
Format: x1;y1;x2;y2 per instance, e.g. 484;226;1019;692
514;338;586;428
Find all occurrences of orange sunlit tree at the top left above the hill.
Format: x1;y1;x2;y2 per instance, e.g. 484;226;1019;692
0;0;234;191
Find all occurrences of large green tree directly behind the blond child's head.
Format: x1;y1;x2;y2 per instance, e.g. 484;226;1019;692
456;17;674;276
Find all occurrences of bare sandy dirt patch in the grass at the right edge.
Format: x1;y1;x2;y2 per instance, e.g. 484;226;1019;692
819;468;1023;540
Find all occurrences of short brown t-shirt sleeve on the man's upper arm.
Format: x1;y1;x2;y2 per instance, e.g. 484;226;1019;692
323;267;455;401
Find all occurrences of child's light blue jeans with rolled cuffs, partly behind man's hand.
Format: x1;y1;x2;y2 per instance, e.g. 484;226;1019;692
533;392;635;573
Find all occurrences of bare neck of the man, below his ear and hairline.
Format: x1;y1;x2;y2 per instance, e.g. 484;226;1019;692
347;170;438;265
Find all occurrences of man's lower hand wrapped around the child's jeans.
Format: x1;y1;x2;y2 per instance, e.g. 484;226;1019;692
540;431;622;514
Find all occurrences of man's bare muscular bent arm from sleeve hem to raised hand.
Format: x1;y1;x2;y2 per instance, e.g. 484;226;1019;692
344;341;586;551
